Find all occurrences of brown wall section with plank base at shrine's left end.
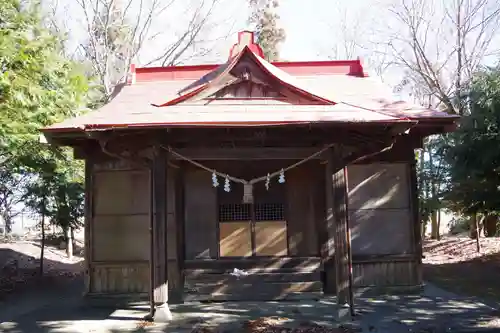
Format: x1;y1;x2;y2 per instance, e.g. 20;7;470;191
87;161;150;294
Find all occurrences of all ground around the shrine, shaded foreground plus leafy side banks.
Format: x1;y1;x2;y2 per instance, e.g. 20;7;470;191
0;232;500;333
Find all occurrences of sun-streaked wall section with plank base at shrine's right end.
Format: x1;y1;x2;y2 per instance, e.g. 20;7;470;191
348;162;421;287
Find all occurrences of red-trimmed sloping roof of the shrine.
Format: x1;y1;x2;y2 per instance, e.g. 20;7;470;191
45;30;457;132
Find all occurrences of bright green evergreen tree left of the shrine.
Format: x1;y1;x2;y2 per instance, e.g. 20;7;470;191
0;0;89;236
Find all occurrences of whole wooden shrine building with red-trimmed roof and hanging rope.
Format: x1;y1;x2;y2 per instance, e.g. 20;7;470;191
42;31;457;316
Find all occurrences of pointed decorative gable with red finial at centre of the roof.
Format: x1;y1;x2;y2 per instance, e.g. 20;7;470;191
153;31;336;107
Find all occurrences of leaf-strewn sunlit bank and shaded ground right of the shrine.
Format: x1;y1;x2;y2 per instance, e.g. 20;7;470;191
423;236;500;302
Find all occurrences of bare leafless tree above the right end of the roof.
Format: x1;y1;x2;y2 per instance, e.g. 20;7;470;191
376;0;500;114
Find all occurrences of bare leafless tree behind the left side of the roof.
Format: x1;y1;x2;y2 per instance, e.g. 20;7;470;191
76;0;231;102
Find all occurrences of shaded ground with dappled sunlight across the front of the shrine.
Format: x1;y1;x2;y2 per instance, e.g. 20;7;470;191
0;287;500;333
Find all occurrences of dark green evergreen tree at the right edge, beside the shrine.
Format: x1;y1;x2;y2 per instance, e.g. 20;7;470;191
446;68;500;233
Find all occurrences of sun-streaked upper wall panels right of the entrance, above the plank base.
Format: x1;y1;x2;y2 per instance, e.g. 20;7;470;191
347;163;412;255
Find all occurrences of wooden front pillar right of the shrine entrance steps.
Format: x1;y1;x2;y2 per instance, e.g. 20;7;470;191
327;149;352;305
